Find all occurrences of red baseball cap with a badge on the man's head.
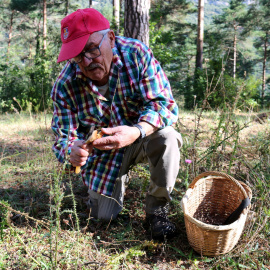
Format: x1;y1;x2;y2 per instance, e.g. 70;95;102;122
57;8;110;63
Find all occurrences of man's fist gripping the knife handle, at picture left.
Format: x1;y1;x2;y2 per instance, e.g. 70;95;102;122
70;141;93;167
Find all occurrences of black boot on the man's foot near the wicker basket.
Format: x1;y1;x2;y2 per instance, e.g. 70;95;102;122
146;203;176;240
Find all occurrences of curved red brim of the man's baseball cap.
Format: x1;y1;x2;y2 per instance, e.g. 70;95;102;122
57;34;91;63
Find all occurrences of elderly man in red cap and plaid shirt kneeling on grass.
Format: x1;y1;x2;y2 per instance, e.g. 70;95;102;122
52;8;182;238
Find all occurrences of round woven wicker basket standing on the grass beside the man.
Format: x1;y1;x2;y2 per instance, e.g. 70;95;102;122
181;172;252;256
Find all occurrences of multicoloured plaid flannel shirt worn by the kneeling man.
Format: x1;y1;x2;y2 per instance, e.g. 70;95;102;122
51;37;178;196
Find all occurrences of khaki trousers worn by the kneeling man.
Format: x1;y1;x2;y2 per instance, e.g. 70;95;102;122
88;126;182;220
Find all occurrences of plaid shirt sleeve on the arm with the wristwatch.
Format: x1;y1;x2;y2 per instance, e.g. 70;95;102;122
139;49;178;128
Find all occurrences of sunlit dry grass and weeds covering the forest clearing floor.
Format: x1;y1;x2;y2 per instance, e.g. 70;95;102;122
0;110;270;269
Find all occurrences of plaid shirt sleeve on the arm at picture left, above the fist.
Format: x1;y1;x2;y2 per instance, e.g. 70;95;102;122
51;83;78;162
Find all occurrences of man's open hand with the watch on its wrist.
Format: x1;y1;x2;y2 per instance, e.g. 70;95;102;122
93;126;140;150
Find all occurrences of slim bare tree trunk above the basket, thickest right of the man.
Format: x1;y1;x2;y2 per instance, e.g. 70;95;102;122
196;0;204;69
